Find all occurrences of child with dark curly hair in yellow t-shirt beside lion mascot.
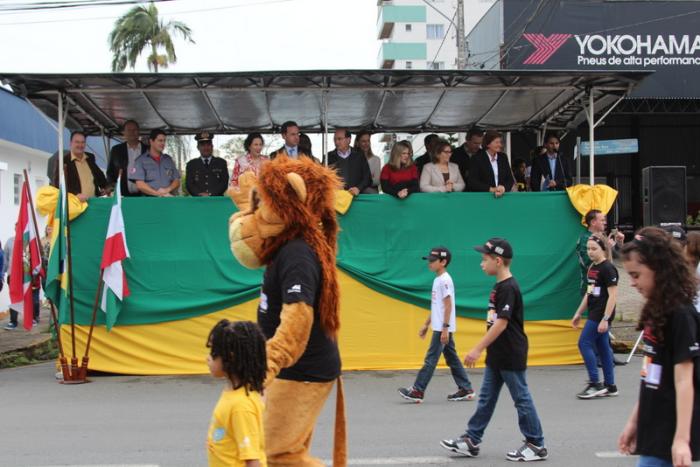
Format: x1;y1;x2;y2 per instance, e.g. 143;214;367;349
207;319;267;467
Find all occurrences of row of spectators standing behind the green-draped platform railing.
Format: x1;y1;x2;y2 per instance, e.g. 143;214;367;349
50;120;572;201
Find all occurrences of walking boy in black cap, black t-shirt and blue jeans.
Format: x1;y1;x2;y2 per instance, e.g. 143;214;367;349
440;238;548;462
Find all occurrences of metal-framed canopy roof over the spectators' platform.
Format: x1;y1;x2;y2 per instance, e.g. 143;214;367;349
0;70;650;135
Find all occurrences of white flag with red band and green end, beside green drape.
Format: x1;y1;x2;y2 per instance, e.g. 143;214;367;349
100;176;129;330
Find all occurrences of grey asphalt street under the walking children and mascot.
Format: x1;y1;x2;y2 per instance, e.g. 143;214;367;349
0;357;652;467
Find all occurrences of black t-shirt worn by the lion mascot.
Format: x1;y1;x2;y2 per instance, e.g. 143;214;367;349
258;239;340;382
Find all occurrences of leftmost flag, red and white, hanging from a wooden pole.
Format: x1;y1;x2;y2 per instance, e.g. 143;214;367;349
8;180;44;330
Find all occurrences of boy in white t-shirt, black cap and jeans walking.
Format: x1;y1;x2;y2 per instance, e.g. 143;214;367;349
399;247;474;403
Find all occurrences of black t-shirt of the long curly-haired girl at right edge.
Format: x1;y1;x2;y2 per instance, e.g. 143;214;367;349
637;304;700;461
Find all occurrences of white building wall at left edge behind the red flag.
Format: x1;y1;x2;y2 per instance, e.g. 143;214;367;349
0;139;51;310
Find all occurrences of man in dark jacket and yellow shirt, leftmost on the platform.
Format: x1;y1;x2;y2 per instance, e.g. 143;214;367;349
51;130;110;201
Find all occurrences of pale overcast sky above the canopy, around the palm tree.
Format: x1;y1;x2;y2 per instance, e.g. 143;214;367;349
0;0;493;157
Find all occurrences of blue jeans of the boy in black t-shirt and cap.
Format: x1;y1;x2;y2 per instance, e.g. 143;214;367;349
466;365;544;446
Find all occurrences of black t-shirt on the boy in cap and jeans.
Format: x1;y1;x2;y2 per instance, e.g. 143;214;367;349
486;277;528;370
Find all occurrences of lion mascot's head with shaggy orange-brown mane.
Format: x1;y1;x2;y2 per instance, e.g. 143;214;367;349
229;157;342;337
